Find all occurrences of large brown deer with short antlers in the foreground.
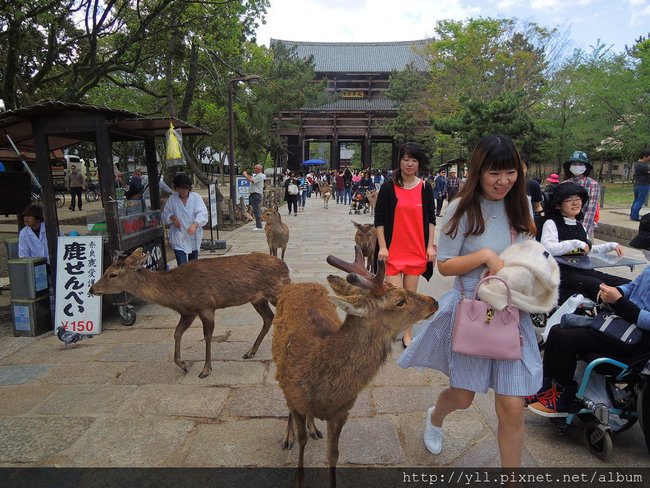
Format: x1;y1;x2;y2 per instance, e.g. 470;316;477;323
272;246;438;468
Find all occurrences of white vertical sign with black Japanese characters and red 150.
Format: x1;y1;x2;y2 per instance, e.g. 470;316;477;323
54;236;103;334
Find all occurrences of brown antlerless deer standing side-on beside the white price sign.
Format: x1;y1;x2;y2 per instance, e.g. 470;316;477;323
90;248;291;378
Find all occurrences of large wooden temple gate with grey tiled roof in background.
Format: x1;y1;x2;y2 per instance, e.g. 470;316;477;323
271;39;428;170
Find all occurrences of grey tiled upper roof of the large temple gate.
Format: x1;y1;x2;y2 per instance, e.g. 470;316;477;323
271;39;429;73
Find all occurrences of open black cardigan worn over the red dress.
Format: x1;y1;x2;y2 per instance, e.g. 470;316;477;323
375;180;436;281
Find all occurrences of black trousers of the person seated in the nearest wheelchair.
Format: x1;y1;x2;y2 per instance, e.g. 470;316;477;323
543;325;648;386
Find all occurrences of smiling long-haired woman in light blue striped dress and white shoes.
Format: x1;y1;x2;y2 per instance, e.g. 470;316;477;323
398;135;542;468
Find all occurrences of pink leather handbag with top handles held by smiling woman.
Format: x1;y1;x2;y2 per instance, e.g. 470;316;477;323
451;276;523;360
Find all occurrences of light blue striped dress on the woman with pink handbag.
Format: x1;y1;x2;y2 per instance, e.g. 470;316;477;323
397;199;542;396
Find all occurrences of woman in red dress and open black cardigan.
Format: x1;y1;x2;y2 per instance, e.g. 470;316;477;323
375;142;436;347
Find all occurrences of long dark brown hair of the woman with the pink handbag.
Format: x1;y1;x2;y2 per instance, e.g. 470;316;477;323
443;135;536;238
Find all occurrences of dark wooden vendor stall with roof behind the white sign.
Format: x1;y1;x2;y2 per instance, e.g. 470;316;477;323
0;102;207;325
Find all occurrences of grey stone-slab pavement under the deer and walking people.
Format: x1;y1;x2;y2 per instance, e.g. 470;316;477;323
0;194;650;467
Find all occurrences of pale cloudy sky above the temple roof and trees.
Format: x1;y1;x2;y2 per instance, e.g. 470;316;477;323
257;0;650;52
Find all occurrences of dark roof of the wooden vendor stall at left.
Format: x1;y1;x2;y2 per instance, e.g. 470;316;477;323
0;101;208;152
